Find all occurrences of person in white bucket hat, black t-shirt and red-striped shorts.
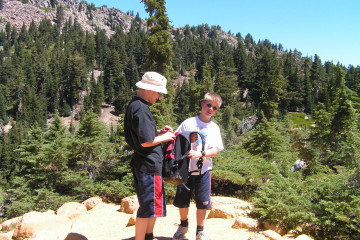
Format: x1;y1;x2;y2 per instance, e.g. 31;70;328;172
124;72;175;240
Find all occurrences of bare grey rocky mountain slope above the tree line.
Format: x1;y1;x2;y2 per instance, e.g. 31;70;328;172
0;0;237;46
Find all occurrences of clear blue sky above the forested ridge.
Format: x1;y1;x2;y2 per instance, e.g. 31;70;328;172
88;0;360;67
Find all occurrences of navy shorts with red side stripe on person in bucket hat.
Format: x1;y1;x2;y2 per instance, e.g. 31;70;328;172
133;168;166;218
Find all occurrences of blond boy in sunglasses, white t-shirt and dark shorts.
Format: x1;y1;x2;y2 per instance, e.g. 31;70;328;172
173;93;224;240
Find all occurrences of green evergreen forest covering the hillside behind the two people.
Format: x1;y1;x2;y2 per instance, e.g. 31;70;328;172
0;0;360;239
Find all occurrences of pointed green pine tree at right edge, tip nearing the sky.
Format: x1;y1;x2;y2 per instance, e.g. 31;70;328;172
311;65;359;169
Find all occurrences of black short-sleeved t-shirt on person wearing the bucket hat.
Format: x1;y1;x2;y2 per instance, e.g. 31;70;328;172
124;97;163;175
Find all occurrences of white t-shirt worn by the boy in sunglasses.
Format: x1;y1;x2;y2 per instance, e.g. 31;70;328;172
176;116;224;175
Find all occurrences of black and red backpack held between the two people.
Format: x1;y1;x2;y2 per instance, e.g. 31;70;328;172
162;131;205;185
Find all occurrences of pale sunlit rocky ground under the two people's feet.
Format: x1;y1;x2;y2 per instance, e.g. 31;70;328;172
0;196;311;240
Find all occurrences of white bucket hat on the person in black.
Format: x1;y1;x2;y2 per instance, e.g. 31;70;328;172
135;72;167;94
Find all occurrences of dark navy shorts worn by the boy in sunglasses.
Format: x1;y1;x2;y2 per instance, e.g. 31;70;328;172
173;171;211;209
